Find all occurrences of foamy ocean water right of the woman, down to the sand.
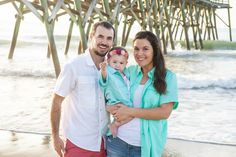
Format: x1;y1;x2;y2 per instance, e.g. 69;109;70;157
167;50;236;144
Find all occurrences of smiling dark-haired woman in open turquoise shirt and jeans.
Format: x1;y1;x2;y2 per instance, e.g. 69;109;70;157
107;31;178;157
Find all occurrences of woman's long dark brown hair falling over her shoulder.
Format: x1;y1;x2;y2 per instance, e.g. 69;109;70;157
133;31;166;94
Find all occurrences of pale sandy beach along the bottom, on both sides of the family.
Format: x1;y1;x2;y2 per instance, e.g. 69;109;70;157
0;131;236;157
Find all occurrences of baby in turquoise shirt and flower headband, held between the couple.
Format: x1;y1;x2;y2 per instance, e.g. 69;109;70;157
99;47;132;137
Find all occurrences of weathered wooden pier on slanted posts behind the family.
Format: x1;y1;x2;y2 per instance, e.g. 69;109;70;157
0;0;232;76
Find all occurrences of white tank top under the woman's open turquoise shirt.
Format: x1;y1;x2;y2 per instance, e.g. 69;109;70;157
117;85;144;146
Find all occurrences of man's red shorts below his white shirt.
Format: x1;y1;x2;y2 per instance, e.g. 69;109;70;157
64;139;106;157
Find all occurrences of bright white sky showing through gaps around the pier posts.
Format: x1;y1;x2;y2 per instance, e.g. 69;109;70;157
0;0;236;39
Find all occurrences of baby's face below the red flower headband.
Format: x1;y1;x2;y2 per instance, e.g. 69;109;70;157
108;55;127;73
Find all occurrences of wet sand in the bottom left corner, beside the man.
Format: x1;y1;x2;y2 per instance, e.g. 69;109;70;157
0;131;57;157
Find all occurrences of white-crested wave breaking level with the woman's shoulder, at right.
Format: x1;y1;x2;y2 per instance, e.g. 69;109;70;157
178;76;236;89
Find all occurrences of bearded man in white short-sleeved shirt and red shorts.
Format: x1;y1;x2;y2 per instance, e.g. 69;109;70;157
51;22;115;157
